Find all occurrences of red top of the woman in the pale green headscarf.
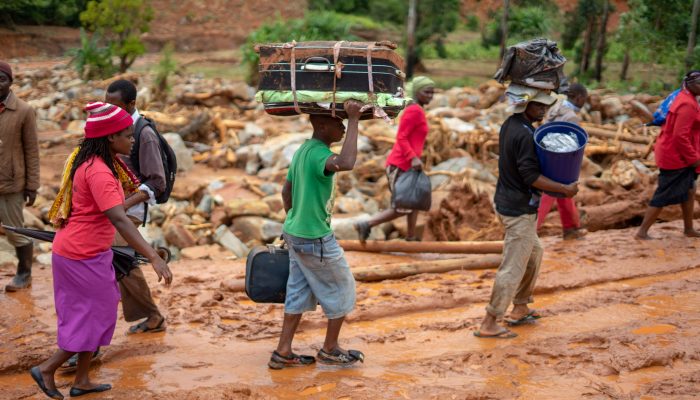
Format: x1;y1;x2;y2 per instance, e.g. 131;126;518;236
386;103;428;171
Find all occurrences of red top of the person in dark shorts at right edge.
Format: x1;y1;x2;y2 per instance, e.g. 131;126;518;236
654;89;700;172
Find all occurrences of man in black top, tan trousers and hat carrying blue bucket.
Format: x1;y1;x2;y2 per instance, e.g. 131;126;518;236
474;84;578;339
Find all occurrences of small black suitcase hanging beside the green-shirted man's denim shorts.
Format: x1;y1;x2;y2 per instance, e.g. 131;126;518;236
245;246;289;304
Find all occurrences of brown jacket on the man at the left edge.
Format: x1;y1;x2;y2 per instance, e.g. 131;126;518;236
0;92;39;194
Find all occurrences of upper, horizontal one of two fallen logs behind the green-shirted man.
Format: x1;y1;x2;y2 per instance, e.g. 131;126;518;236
338;240;503;254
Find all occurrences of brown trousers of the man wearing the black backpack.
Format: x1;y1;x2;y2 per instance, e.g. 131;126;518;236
114;218;161;322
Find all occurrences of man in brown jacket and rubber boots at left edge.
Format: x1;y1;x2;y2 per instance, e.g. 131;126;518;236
0;61;39;292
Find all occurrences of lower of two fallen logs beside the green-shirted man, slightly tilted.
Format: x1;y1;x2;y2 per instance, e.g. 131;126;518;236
352;255;501;282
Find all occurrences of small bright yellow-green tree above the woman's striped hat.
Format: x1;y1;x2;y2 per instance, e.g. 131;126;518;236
80;0;153;73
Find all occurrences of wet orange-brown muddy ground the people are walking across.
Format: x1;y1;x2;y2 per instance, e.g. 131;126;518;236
0;212;700;399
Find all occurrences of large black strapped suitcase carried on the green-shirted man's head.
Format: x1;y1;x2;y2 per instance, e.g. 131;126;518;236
256;42;405;94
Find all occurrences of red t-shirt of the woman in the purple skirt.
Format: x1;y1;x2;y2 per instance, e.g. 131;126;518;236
53;157;124;260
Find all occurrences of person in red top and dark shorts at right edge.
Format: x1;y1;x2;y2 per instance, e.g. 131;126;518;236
635;71;700;239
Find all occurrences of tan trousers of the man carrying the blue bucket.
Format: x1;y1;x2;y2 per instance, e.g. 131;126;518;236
486;214;544;318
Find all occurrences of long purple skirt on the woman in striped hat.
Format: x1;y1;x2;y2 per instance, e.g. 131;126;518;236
52;249;121;353
